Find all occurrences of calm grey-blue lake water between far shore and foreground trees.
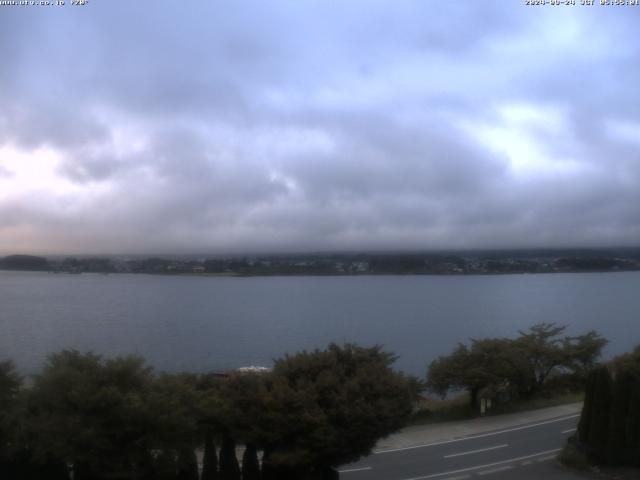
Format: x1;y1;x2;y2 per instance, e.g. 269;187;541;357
0;272;640;375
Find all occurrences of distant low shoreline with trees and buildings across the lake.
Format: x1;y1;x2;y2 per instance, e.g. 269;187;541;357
0;250;640;275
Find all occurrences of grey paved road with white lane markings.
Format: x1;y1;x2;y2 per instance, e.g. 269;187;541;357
340;413;580;480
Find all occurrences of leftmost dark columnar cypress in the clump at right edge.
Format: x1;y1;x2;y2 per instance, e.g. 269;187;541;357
587;366;612;465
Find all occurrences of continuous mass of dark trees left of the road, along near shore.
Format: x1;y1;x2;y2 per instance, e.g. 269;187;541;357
0;344;416;480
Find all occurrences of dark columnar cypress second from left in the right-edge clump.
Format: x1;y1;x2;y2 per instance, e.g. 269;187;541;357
607;371;633;465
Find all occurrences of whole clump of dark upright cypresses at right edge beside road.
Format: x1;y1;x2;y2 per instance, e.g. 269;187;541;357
570;345;640;467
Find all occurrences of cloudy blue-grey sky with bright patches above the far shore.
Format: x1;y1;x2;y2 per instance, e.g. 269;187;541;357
0;0;640;254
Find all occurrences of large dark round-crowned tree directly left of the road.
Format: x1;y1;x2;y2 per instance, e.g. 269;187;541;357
258;344;413;479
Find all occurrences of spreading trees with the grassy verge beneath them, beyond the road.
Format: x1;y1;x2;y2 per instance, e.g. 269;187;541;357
420;323;607;423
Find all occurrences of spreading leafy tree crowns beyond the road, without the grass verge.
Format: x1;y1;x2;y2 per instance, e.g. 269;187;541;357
427;323;607;409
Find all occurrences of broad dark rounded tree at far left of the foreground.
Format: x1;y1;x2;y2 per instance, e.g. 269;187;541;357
29;351;154;480
